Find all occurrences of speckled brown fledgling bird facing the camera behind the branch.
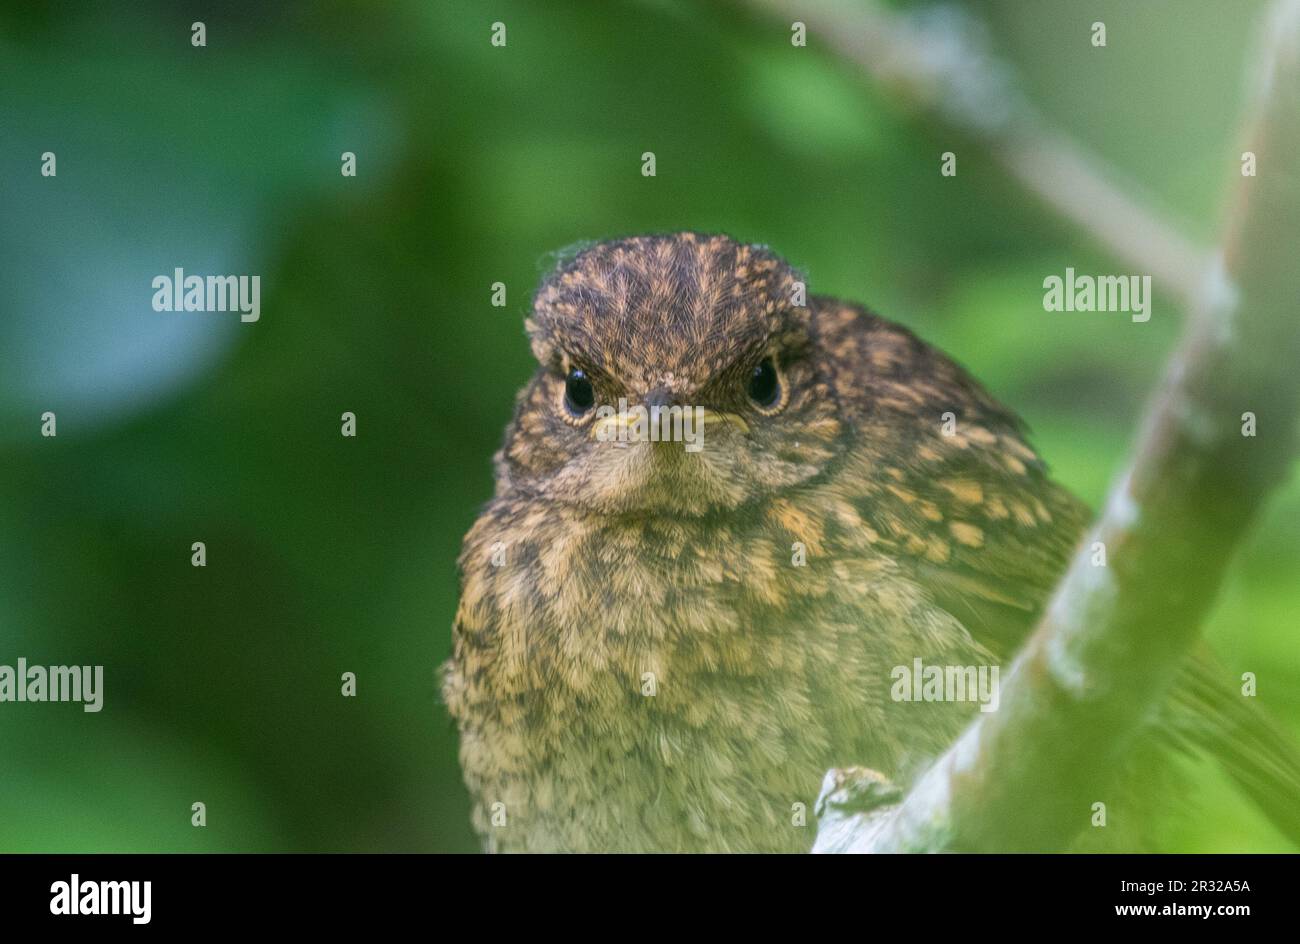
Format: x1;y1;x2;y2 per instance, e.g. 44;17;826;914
442;231;1300;853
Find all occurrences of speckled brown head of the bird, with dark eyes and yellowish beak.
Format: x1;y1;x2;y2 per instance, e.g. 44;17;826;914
501;233;841;515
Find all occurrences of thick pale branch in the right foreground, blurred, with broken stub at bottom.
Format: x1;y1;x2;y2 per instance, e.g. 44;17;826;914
815;0;1300;852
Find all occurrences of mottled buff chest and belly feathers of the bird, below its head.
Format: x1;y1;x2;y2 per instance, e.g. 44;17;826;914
447;496;956;846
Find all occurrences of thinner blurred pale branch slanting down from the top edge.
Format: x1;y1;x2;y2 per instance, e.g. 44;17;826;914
741;0;1208;309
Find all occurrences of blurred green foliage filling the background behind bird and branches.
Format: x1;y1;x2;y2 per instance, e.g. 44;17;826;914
0;0;1300;850
